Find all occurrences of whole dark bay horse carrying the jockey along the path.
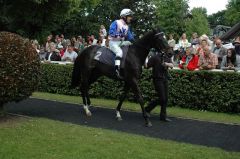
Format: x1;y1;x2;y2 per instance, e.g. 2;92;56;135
72;30;172;127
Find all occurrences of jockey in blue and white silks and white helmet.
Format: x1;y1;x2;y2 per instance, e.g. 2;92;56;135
109;9;134;77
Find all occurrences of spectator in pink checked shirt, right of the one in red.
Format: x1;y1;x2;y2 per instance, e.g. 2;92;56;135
198;46;218;70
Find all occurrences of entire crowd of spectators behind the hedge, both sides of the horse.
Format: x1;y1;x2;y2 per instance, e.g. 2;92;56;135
32;25;240;71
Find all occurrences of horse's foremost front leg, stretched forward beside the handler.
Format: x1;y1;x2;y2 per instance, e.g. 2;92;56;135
131;80;152;127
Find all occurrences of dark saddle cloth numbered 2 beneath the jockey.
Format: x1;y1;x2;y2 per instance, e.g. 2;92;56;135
94;45;129;68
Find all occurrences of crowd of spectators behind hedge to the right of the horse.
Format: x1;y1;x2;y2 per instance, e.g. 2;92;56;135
168;33;240;71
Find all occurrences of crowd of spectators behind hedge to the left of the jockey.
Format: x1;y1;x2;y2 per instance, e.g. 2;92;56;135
32;25;109;63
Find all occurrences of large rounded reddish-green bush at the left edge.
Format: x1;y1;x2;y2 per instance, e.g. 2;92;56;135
0;32;40;107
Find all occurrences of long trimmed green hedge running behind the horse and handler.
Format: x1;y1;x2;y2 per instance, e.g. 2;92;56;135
39;64;240;113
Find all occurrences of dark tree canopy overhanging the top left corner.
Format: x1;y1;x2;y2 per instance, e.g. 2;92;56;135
0;0;80;39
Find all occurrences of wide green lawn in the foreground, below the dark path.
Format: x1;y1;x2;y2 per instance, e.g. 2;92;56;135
0;118;240;159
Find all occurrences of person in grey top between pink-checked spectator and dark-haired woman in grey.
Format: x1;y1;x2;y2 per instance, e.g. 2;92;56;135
213;39;227;69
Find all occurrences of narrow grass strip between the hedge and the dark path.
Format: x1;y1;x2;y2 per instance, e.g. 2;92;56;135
32;92;240;124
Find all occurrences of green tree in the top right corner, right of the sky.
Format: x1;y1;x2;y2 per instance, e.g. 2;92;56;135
225;0;240;26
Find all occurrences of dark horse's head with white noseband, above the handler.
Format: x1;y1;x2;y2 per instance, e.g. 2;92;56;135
152;30;173;54
